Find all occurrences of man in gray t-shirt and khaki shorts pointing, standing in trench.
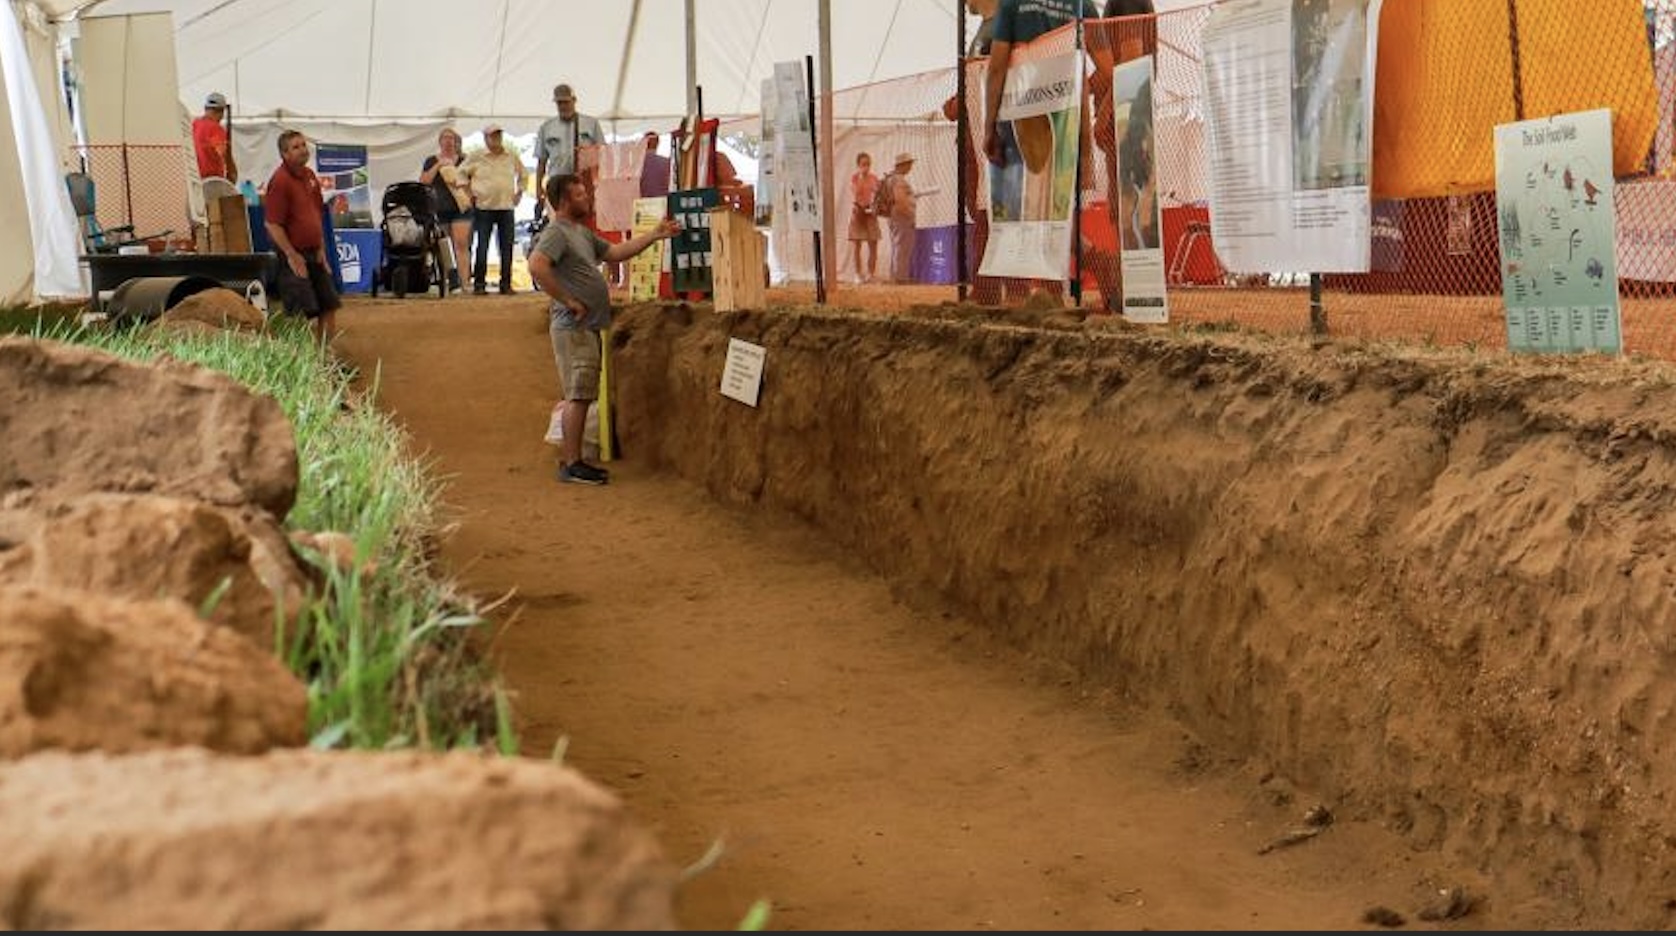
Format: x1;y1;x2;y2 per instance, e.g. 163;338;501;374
530;173;680;485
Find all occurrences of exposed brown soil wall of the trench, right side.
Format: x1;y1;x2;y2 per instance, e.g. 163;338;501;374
612;305;1676;926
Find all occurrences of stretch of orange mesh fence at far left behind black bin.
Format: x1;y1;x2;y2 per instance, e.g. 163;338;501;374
69;144;198;248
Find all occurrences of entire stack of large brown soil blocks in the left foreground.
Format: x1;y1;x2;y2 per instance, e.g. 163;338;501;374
0;335;675;929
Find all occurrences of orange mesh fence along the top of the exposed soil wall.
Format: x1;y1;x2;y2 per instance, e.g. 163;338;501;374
750;0;1676;359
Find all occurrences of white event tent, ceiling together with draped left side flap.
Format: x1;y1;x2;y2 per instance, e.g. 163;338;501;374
0;0;975;304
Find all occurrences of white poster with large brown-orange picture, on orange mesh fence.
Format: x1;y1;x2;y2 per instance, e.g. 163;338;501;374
977;52;1083;280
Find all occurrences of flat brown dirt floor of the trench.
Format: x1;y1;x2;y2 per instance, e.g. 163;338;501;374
323;295;1508;929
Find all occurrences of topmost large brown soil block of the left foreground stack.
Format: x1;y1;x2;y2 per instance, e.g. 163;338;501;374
0;337;297;518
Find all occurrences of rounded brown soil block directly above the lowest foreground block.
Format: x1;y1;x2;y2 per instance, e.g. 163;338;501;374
0;585;308;758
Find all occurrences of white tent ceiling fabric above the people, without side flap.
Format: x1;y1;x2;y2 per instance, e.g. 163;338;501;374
65;0;977;133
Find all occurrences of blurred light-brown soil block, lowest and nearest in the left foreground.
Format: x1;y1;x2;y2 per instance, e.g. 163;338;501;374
0;750;675;929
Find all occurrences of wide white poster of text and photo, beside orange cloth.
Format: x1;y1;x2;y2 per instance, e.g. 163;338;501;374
1202;0;1383;273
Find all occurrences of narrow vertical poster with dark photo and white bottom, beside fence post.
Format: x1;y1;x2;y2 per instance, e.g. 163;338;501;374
1111;55;1170;324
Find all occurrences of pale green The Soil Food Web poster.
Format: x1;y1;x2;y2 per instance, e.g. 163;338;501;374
1495;111;1624;354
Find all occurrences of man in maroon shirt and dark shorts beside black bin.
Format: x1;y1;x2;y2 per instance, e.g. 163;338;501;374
261;131;344;344
